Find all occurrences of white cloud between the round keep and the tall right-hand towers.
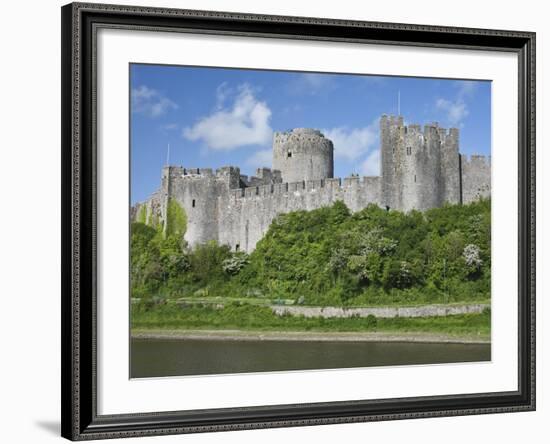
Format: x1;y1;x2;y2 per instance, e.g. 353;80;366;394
323;119;379;160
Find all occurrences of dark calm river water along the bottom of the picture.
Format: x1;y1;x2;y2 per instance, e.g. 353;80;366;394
131;339;491;378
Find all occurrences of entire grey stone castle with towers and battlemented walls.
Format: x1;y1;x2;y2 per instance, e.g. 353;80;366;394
131;115;491;252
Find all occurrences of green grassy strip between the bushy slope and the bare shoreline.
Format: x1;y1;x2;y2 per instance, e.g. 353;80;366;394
131;304;491;339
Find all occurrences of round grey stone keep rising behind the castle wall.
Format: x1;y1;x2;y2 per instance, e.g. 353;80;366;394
273;128;334;182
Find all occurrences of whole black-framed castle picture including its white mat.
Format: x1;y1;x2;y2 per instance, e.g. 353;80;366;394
61;3;535;440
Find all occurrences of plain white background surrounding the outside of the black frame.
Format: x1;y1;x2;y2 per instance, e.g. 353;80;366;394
0;0;550;443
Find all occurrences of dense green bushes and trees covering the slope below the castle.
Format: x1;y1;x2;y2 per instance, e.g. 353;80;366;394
131;200;491;305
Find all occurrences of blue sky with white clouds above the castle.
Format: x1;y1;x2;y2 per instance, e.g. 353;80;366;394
130;64;491;203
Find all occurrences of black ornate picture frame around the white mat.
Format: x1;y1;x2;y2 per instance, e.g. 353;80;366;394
61;3;535;440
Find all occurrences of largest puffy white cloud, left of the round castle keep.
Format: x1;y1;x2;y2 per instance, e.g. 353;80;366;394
182;84;273;151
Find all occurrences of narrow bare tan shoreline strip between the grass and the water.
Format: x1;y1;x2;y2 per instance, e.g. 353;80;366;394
131;329;491;344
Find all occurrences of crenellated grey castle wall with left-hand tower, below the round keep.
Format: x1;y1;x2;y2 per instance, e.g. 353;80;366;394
142;167;381;252
